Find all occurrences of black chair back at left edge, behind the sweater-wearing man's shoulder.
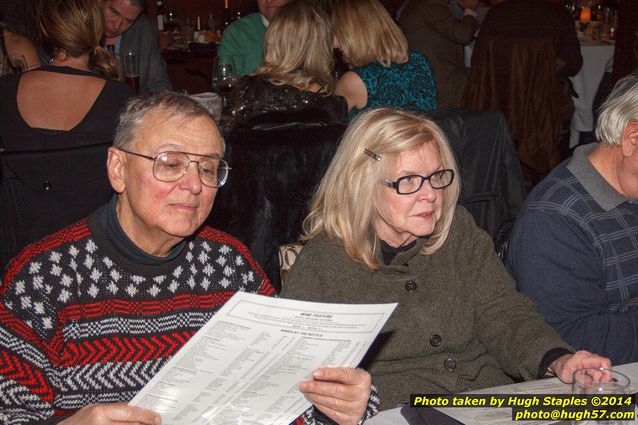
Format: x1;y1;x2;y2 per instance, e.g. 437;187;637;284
0;143;113;268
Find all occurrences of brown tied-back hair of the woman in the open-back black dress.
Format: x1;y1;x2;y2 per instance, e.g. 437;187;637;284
40;0;119;78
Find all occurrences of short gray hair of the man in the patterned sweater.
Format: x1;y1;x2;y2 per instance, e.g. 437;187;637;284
113;91;226;154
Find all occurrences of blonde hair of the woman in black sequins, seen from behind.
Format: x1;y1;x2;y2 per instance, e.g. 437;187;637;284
255;0;335;93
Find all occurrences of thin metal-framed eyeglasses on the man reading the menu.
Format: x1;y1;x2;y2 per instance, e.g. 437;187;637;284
118;148;230;187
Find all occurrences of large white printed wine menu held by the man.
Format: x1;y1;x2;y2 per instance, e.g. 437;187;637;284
130;292;396;425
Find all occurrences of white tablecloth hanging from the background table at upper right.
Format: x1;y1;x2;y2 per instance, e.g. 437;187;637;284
569;44;615;147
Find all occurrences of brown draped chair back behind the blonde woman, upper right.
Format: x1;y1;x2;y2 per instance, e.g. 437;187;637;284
463;35;561;174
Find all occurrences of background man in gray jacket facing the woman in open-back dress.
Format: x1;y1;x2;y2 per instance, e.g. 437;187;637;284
102;0;171;94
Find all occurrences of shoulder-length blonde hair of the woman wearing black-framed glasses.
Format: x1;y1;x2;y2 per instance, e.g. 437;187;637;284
301;108;460;270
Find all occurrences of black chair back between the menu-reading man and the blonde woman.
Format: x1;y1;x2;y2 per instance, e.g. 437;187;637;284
207;124;346;286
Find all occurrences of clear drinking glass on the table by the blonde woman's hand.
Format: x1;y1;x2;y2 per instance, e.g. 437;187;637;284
572;368;630;425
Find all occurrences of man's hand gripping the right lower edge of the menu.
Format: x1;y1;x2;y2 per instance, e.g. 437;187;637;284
299;367;372;425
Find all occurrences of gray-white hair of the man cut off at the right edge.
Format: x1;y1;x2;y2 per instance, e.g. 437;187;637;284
596;75;638;145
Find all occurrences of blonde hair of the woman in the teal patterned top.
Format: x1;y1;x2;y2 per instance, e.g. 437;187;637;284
331;0;408;66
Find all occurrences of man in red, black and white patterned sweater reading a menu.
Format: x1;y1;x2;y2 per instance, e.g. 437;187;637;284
0;92;376;425
